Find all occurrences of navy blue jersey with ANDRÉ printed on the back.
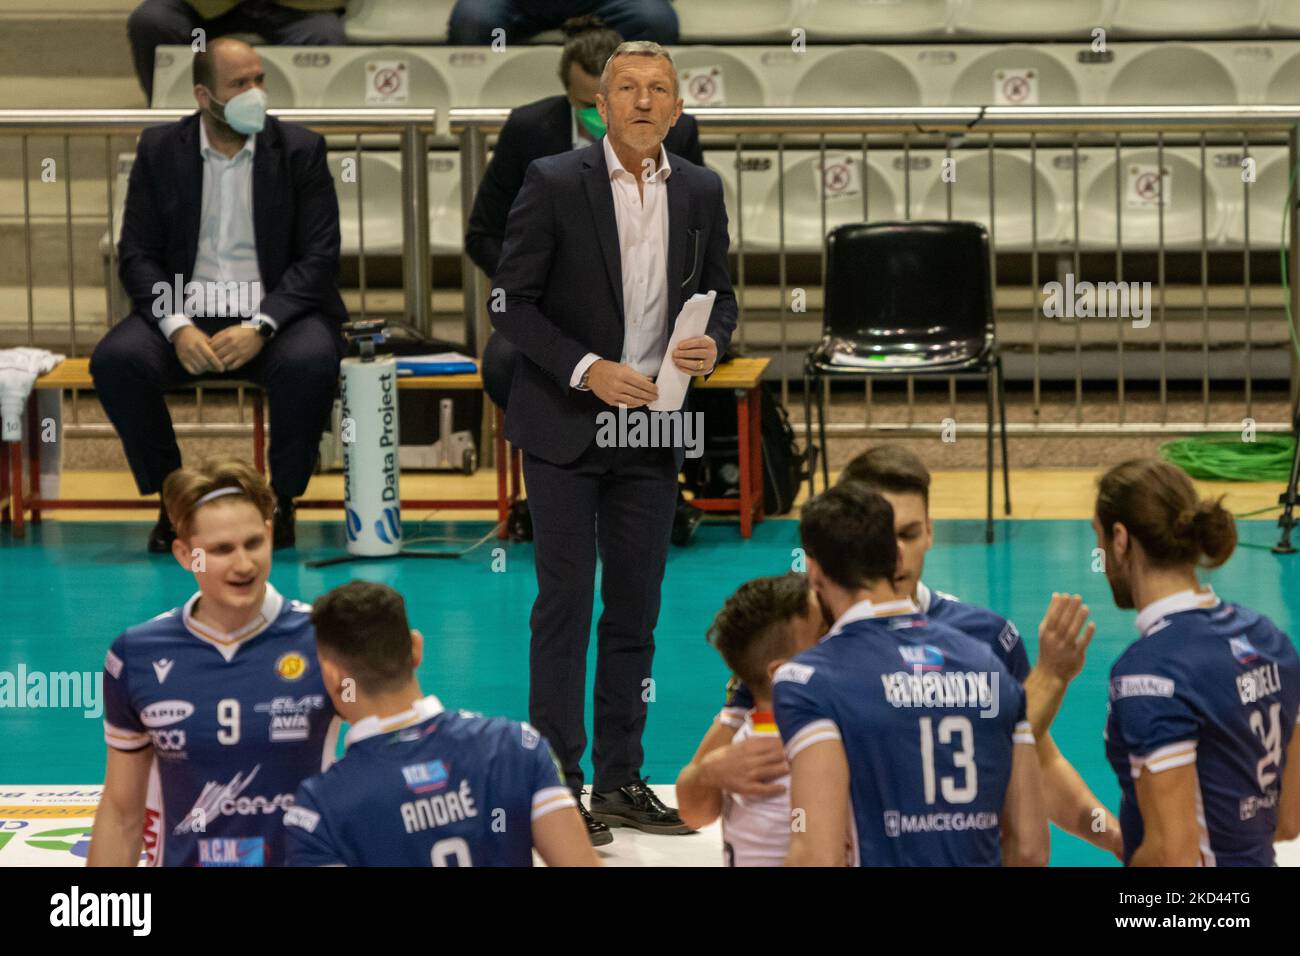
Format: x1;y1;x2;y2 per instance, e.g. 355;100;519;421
285;697;577;866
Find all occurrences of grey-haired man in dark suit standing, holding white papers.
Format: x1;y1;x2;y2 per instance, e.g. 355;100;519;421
491;42;736;843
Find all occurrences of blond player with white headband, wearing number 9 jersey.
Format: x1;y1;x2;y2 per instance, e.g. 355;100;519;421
87;460;339;866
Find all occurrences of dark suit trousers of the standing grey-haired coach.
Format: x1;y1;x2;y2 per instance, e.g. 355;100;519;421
524;441;677;792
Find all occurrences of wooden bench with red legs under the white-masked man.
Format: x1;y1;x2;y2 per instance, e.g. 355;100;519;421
0;359;523;538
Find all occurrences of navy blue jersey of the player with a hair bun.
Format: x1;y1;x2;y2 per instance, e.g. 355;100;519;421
1105;588;1300;866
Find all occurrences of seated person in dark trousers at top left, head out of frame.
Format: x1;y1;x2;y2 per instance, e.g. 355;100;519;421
126;0;347;104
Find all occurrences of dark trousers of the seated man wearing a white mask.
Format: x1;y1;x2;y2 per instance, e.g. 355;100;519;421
90;312;342;497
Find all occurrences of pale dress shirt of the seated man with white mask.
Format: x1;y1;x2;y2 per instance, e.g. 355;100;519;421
159;118;276;341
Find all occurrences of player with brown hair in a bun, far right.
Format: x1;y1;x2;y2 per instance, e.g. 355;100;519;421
1092;459;1300;866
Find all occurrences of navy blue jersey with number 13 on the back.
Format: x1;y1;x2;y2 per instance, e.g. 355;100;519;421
772;601;1034;866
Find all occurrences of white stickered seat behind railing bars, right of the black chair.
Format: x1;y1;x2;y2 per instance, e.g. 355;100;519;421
1067;148;1225;250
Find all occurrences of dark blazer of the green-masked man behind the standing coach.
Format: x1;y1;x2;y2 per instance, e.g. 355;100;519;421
465;95;705;278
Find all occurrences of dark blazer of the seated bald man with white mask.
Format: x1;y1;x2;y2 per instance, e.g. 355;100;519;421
117;113;347;329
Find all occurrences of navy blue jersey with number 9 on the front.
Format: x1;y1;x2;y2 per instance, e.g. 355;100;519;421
104;584;338;866
